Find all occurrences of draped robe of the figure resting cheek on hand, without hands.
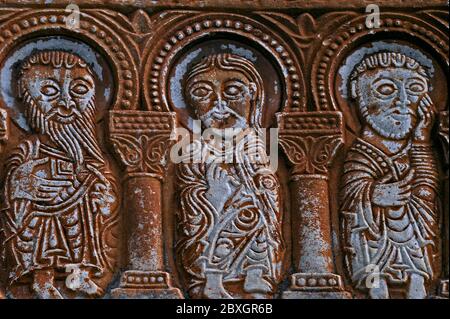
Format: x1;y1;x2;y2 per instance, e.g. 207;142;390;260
341;139;438;287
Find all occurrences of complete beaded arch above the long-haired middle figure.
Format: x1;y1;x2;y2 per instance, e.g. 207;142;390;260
143;14;306;112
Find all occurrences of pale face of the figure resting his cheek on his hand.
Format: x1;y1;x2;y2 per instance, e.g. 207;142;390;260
353;67;428;139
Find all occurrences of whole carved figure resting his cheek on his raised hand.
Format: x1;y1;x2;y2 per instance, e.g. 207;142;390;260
341;52;439;299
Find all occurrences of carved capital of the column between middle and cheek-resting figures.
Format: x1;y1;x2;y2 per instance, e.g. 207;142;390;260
277;111;344;178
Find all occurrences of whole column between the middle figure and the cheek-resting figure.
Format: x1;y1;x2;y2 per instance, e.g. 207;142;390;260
277;112;350;299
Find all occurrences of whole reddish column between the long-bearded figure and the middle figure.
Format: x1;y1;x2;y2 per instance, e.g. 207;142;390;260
109;111;182;299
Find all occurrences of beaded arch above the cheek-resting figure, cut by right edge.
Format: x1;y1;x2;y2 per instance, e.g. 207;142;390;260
311;13;449;111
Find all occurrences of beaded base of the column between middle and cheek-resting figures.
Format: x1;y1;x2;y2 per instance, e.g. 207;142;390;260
281;273;352;299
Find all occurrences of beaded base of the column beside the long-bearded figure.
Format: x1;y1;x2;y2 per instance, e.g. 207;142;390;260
111;270;183;299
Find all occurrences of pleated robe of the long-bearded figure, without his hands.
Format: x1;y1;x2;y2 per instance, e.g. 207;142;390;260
1;139;117;283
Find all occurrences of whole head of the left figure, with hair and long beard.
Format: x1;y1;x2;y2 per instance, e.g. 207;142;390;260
19;51;103;165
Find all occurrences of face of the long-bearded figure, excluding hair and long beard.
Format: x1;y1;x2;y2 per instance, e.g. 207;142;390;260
23;65;95;123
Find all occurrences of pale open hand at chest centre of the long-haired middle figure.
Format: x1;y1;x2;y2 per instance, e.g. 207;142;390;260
206;164;238;212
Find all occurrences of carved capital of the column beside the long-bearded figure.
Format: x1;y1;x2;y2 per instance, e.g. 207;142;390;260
109;110;176;179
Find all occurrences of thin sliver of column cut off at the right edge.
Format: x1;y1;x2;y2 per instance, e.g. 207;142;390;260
439;111;449;298
